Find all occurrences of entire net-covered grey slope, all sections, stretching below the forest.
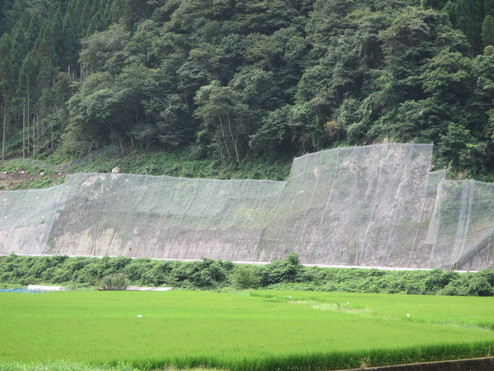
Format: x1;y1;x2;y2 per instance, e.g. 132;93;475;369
0;144;494;270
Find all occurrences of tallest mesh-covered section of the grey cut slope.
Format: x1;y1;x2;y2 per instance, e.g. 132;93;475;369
260;144;432;267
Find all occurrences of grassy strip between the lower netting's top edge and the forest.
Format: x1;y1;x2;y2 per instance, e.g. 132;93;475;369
0;149;293;190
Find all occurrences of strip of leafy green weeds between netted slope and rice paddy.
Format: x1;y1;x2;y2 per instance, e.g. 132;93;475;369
0;254;494;296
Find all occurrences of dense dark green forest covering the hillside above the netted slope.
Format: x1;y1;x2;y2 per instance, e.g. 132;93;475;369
0;0;494;180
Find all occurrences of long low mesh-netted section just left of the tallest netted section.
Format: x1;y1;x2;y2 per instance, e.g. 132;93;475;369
46;174;284;260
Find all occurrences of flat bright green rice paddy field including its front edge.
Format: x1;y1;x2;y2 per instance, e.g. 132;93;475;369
0;290;494;370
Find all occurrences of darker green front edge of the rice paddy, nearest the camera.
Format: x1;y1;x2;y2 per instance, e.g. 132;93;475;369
0;342;494;371
